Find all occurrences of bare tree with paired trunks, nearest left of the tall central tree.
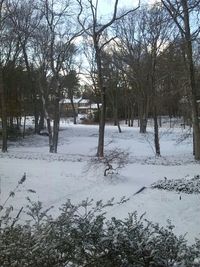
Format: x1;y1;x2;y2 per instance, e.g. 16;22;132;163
41;0;81;153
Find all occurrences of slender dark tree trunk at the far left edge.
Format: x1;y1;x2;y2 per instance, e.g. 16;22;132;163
0;66;7;152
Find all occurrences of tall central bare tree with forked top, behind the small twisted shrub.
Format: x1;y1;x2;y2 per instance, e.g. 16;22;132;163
77;0;140;158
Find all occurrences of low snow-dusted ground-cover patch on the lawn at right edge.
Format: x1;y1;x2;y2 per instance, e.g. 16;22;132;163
151;175;200;194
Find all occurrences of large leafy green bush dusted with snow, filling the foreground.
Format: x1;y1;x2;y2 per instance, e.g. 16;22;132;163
0;200;200;267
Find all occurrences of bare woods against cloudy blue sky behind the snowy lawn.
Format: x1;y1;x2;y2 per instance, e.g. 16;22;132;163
0;0;200;160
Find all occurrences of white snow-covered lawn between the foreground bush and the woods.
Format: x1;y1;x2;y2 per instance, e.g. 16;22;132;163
0;121;200;243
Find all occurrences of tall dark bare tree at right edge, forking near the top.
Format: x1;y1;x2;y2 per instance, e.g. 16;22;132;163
161;0;200;160
